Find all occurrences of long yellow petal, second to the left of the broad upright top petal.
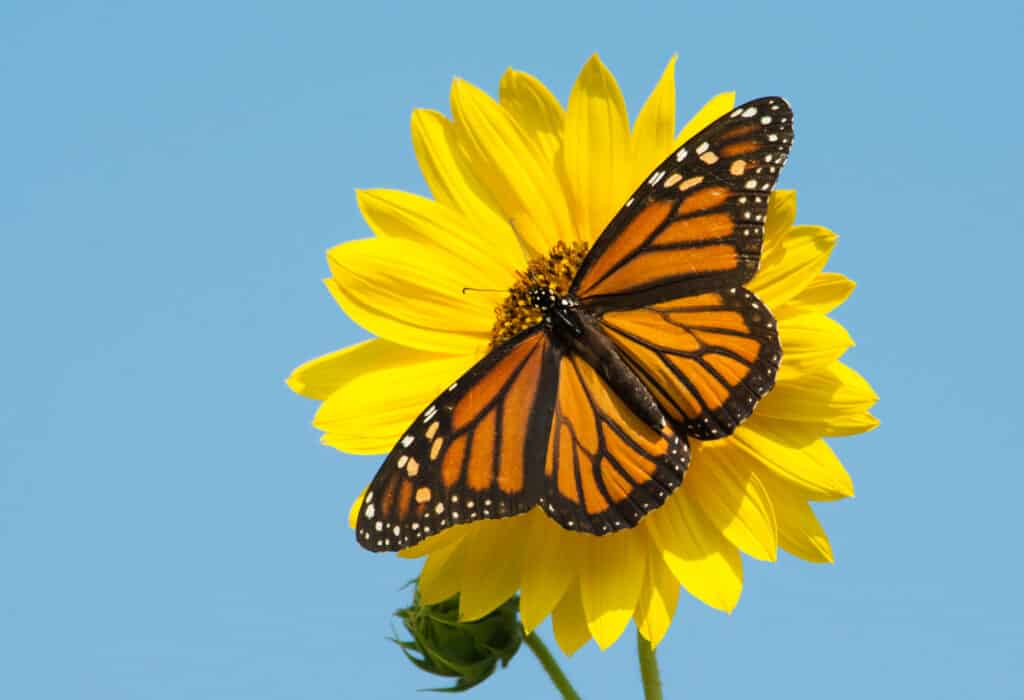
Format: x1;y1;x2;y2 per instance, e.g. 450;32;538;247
452;80;572;258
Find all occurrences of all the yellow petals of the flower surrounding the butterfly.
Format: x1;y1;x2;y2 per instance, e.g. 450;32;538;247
289;56;878;654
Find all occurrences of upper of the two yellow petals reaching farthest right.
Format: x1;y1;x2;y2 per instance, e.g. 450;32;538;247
757;362;879;424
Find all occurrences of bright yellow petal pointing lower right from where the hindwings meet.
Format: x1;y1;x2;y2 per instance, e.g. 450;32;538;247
680;443;778;562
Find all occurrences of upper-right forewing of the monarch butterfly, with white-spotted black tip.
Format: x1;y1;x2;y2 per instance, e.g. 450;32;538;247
570;97;793;313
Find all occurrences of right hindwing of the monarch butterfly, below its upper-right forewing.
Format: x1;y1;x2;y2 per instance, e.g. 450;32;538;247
601;288;782;440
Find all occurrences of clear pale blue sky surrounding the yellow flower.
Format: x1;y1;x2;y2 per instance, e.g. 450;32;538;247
0;0;1024;700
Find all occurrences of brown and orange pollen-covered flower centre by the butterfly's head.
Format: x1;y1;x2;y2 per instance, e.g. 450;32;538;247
490;240;590;347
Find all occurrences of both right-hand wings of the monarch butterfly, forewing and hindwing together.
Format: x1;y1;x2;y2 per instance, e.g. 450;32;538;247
573;97;793;440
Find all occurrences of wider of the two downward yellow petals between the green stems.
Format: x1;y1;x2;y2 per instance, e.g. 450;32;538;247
580;530;650;649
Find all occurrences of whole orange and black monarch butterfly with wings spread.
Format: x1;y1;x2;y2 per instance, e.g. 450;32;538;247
356;97;793;552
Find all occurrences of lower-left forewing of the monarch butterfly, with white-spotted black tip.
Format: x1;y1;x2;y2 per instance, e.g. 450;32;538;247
355;326;557;552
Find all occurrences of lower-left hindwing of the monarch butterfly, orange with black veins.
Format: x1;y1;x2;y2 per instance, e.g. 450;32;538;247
540;353;690;534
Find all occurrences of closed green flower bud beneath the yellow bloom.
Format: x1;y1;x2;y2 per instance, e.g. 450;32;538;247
392;592;522;693
